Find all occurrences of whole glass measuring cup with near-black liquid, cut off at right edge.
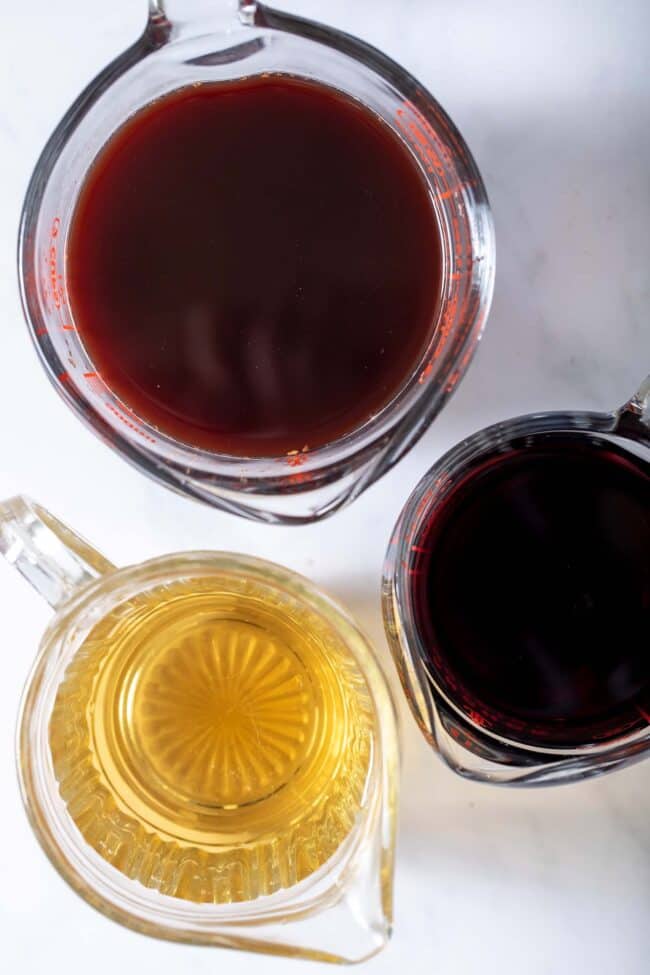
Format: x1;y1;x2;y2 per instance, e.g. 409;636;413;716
384;388;650;784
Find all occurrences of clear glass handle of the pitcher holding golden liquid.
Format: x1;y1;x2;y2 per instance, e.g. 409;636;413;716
0;495;115;609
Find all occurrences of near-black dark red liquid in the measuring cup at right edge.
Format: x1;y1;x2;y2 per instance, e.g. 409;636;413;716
413;436;650;746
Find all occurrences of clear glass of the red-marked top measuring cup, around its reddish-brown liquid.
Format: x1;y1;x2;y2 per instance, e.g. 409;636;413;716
19;0;494;523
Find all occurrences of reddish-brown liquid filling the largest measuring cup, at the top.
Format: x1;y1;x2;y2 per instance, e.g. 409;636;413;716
67;76;441;456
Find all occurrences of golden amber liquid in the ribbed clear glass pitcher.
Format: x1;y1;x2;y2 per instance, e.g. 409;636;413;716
50;577;374;904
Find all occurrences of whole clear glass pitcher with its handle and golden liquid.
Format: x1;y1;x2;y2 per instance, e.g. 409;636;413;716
0;497;399;962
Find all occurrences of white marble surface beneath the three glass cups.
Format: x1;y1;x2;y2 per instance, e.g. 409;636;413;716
0;0;650;975
